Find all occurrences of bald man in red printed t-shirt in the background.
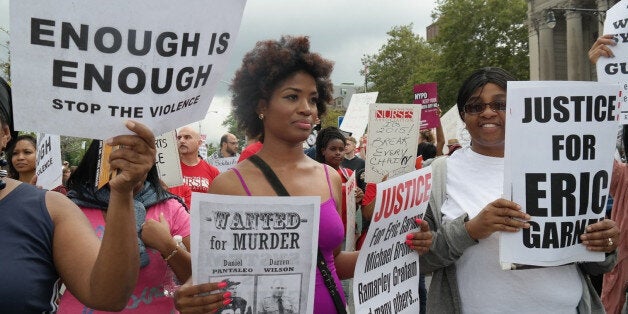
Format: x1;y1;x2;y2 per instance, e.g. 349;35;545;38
169;126;220;208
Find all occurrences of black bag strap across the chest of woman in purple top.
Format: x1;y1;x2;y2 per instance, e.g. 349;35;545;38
248;155;347;314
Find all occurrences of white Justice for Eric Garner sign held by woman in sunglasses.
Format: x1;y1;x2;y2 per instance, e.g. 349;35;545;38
500;82;620;266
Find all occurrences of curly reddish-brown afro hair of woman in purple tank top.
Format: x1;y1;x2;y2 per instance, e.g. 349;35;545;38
229;36;334;139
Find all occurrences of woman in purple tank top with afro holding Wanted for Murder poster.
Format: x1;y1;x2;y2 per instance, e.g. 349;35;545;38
175;36;434;313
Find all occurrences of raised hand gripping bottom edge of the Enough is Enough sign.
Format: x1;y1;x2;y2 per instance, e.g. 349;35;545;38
105;121;156;193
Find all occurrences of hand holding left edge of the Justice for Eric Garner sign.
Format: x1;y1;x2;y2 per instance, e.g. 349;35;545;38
465;198;530;240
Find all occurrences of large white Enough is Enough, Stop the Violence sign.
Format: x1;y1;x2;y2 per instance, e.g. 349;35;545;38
10;0;246;139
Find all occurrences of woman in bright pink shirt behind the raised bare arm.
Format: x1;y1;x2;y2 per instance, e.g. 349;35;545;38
58;140;192;314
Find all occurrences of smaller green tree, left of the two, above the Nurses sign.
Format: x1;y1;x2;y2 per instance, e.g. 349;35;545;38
361;24;436;104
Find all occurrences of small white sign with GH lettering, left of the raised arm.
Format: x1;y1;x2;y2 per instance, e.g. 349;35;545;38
35;133;63;190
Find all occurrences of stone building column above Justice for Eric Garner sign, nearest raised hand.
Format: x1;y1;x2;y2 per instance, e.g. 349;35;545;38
565;11;585;81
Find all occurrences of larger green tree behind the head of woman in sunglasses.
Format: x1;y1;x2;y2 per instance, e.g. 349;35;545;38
432;0;530;111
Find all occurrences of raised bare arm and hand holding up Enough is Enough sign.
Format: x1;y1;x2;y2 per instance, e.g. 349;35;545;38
51;122;155;311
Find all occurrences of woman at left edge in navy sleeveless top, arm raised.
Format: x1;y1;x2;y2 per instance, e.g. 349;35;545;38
0;79;155;313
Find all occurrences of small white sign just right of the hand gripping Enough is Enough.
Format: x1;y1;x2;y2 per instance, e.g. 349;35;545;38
155;131;183;187
